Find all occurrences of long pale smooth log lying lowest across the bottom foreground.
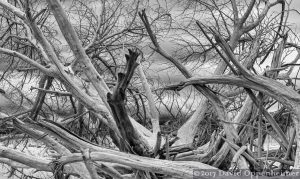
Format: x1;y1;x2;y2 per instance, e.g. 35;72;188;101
0;146;219;178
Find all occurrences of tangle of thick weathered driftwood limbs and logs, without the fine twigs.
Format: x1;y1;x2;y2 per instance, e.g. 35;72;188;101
0;0;300;178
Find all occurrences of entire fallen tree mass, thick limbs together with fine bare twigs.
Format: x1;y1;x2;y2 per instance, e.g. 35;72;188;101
0;0;300;178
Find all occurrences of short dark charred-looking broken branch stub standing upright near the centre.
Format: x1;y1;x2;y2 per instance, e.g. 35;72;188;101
107;50;149;155
